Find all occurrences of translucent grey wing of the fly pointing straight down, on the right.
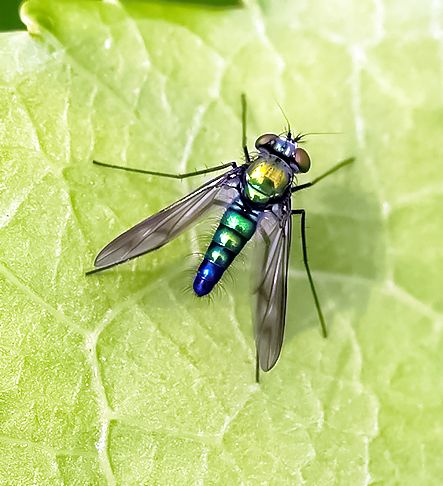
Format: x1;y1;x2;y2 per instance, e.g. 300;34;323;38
254;198;292;371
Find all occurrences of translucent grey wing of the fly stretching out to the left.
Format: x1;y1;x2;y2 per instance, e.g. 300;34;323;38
94;167;242;269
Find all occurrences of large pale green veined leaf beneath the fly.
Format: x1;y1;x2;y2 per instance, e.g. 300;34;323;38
0;0;443;486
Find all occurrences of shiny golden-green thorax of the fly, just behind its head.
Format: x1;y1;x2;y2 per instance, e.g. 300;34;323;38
245;156;292;204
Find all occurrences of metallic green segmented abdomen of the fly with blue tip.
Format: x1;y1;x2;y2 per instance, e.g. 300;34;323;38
193;203;257;297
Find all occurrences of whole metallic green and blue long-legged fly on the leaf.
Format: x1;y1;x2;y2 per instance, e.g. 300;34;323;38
87;94;354;382
